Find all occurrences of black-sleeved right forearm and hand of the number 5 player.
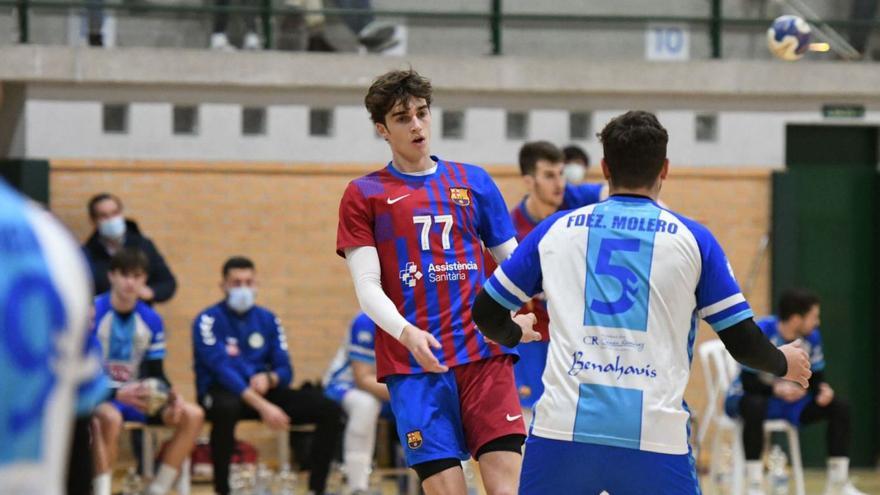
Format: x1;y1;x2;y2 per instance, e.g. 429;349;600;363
718;318;812;388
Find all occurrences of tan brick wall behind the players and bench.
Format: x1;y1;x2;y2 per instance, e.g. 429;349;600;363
50;160;770;422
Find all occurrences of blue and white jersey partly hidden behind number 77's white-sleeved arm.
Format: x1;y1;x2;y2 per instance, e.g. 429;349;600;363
323;313;376;402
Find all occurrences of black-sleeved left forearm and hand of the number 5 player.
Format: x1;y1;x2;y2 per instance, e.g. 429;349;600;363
472;290;541;347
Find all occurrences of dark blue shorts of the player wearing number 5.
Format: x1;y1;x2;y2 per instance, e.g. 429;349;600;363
519;435;700;495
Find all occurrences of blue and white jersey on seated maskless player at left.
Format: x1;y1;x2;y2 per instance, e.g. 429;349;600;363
92;292;165;388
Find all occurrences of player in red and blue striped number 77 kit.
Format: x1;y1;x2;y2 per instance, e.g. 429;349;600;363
336;70;537;495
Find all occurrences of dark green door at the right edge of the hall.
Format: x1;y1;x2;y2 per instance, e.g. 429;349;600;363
773;125;880;466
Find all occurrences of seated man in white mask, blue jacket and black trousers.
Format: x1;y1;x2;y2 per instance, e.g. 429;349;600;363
193;256;342;495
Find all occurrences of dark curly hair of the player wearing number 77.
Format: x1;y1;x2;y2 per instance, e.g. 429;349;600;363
364;68;433;124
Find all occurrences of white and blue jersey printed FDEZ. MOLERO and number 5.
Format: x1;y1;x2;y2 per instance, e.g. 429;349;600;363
485;195;752;454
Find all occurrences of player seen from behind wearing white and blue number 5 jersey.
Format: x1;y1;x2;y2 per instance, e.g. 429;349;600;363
474;111;810;495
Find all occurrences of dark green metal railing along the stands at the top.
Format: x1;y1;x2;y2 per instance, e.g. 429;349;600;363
0;0;880;58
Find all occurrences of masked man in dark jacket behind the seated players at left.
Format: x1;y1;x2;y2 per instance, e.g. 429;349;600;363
83;193;177;304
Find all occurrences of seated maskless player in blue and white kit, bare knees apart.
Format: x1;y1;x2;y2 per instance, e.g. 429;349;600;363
92;248;204;495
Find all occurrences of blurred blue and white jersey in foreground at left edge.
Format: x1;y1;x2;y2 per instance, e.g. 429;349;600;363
0;180;107;495
